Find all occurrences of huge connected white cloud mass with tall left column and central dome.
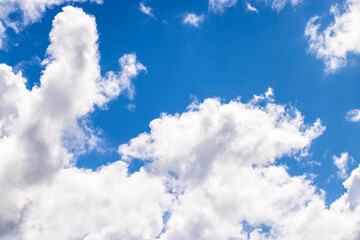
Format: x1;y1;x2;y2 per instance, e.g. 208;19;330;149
0;3;360;240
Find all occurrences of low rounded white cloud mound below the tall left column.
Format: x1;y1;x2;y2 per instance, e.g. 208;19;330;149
20;162;173;240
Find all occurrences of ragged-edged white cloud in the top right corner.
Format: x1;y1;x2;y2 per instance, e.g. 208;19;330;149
305;0;360;72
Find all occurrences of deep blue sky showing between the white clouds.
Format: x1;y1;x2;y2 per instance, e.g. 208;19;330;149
0;0;360;239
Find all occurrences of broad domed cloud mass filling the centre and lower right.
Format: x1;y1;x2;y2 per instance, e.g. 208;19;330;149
119;89;360;240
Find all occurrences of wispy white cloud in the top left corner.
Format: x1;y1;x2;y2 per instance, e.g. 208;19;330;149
0;0;102;48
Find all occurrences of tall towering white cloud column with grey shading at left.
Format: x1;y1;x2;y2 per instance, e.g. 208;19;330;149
0;7;144;238
